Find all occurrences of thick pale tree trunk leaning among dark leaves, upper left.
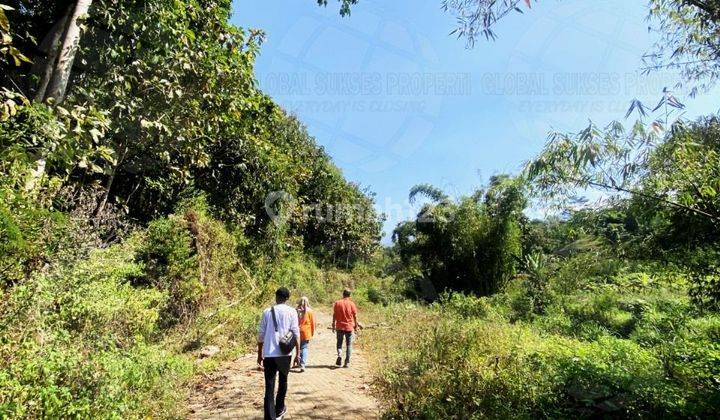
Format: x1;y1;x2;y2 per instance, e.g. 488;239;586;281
46;0;92;104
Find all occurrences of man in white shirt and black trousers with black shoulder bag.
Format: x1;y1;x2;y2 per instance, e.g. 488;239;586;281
257;287;300;420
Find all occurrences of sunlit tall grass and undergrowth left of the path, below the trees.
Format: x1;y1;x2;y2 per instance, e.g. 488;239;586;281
0;199;394;418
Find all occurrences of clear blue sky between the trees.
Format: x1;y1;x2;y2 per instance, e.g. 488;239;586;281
232;0;720;243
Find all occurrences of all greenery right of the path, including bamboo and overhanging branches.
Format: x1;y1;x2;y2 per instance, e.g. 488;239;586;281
366;0;720;419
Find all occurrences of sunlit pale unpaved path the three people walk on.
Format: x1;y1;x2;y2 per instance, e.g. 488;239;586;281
190;310;379;420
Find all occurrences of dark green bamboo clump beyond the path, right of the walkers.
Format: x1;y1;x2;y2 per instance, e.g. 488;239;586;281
393;176;526;298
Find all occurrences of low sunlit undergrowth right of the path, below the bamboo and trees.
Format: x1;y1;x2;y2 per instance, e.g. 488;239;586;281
378;255;720;418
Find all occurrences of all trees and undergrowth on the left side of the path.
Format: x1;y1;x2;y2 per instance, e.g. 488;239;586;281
0;0;380;418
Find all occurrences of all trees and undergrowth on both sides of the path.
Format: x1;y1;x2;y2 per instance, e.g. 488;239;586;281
0;0;720;419
